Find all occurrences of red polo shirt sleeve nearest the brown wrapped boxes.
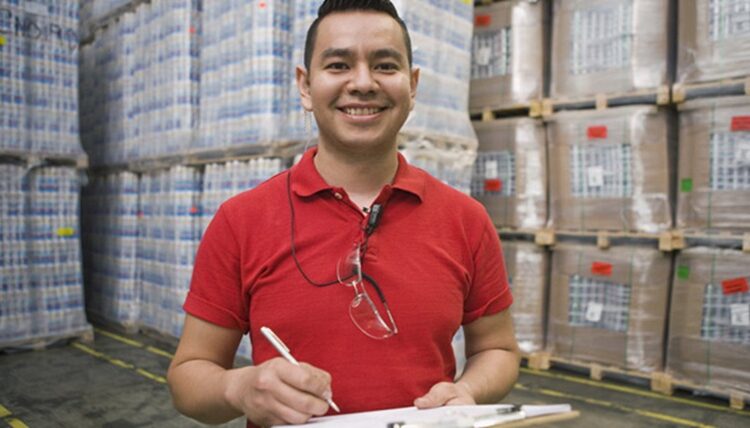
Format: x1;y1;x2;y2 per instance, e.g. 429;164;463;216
461;216;513;324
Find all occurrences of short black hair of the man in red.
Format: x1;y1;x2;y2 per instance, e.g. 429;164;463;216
305;0;412;71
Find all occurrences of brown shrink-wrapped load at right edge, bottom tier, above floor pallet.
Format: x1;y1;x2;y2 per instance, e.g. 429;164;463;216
667;247;750;391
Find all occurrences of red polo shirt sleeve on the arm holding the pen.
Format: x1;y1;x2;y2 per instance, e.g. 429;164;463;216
183;208;249;332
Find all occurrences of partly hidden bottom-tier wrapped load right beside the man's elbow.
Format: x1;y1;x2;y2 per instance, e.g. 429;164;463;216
503;240;549;353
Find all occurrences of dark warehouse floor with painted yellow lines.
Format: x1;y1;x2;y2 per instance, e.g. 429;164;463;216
0;328;750;428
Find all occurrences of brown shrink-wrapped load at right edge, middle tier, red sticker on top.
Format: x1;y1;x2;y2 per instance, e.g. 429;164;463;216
677;97;750;231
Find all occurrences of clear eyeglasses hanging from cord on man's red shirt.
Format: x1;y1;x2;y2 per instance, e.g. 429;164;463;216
336;244;398;339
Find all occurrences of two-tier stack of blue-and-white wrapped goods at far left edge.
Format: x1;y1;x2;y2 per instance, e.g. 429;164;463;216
0;0;93;349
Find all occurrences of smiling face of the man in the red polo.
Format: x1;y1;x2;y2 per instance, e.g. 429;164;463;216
297;11;419;153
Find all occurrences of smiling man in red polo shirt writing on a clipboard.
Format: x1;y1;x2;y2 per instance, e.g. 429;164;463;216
168;0;519;426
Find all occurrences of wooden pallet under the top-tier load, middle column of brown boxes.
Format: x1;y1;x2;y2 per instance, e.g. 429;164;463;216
541;85;672;118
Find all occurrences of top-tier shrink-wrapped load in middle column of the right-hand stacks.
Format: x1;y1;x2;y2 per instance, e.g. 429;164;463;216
550;0;672;99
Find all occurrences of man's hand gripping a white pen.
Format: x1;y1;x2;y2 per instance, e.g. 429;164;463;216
225;358;331;426
